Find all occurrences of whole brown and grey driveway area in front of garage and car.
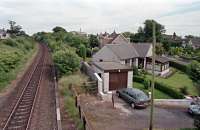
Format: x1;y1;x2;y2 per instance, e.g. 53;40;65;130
81;94;194;130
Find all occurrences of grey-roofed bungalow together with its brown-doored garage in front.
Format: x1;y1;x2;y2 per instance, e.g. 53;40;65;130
92;43;169;98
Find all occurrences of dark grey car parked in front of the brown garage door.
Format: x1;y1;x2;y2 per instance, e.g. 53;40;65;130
116;88;150;108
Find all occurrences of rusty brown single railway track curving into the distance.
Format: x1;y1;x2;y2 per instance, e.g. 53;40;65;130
3;45;48;130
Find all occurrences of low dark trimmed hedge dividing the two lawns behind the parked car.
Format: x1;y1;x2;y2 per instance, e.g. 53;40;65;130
133;76;184;99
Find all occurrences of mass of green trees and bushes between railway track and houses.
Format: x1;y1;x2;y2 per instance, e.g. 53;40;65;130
33;27;98;76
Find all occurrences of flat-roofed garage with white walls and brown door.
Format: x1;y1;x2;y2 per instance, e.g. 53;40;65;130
93;62;133;94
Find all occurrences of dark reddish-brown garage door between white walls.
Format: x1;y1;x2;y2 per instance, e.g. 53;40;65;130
109;72;128;90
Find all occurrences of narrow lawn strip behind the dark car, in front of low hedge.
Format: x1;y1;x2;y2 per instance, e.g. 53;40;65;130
133;82;172;99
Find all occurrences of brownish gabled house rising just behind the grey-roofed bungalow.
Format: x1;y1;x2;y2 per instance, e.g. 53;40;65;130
99;31;130;48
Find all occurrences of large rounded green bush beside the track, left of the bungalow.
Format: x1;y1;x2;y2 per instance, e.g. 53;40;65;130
53;49;80;75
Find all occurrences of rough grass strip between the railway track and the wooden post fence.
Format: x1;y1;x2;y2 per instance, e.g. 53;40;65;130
59;72;88;130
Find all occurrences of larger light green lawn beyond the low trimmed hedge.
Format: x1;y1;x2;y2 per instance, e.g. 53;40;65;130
147;71;198;95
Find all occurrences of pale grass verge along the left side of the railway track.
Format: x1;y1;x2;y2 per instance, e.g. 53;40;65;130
0;42;38;93
